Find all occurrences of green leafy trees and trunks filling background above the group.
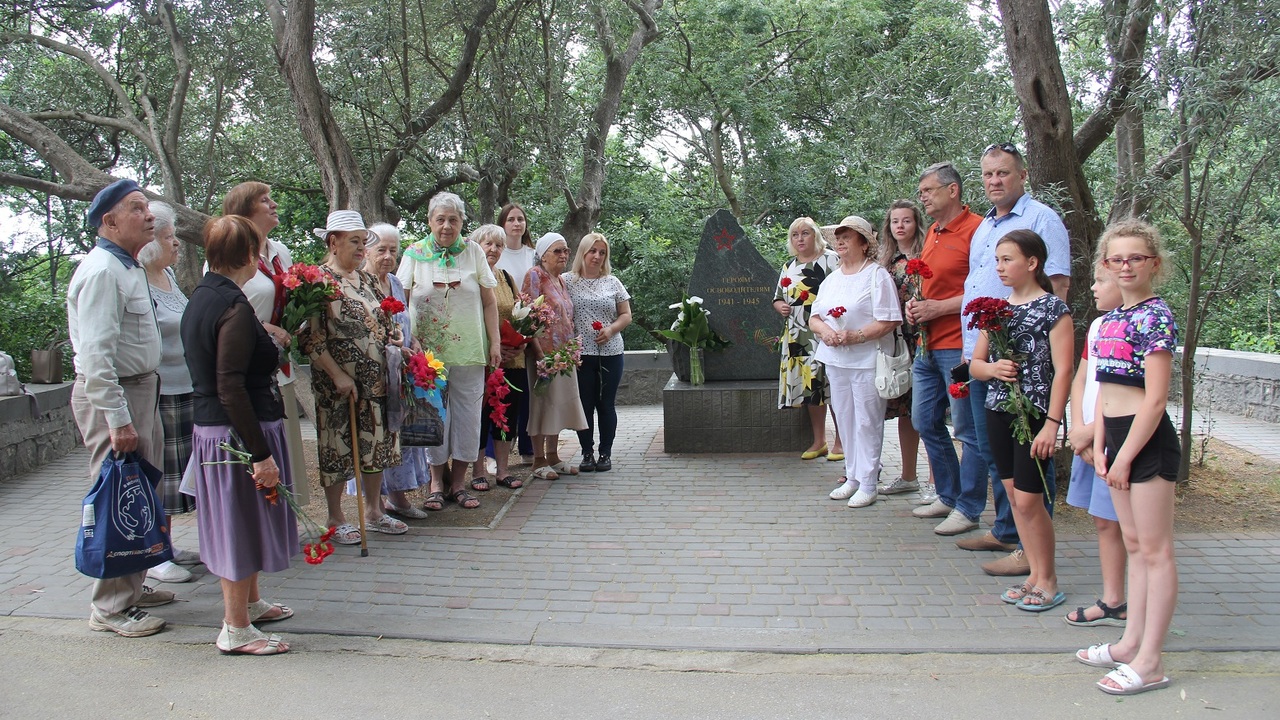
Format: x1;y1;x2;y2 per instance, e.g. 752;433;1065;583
0;0;1280;417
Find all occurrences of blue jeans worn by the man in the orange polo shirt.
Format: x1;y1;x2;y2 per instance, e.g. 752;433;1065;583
911;348;987;519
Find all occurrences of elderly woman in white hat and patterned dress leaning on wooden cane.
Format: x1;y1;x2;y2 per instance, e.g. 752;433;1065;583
298;210;408;544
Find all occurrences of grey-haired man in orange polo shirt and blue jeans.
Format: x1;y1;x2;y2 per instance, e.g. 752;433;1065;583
906;163;987;536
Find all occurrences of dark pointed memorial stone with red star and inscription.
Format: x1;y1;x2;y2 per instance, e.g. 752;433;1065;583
673;210;782;382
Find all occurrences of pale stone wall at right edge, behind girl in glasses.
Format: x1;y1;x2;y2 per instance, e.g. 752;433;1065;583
1169;347;1280;423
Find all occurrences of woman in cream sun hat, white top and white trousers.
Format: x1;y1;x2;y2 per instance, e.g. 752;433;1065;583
809;215;902;507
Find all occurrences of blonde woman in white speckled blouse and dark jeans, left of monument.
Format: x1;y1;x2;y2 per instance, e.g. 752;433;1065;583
562;232;631;473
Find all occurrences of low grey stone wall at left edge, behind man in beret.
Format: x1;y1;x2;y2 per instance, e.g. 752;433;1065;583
0;383;83;482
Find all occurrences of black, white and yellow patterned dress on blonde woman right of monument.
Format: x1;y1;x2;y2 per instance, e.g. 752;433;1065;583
773;250;840;407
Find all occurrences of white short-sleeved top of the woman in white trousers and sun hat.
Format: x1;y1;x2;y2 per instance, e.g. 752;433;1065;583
812;261;902;369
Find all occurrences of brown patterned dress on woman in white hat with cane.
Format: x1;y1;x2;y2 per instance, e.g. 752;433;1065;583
298;265;401;487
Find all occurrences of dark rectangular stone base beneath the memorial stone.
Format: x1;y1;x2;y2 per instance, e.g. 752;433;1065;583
662;374;813;452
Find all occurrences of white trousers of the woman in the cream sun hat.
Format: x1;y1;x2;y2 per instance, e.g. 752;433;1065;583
827;365;888;492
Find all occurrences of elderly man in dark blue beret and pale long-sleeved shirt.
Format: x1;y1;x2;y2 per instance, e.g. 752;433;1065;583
67;179;174;638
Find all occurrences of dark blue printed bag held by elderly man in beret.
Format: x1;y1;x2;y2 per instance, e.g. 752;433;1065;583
76;451;173;578
